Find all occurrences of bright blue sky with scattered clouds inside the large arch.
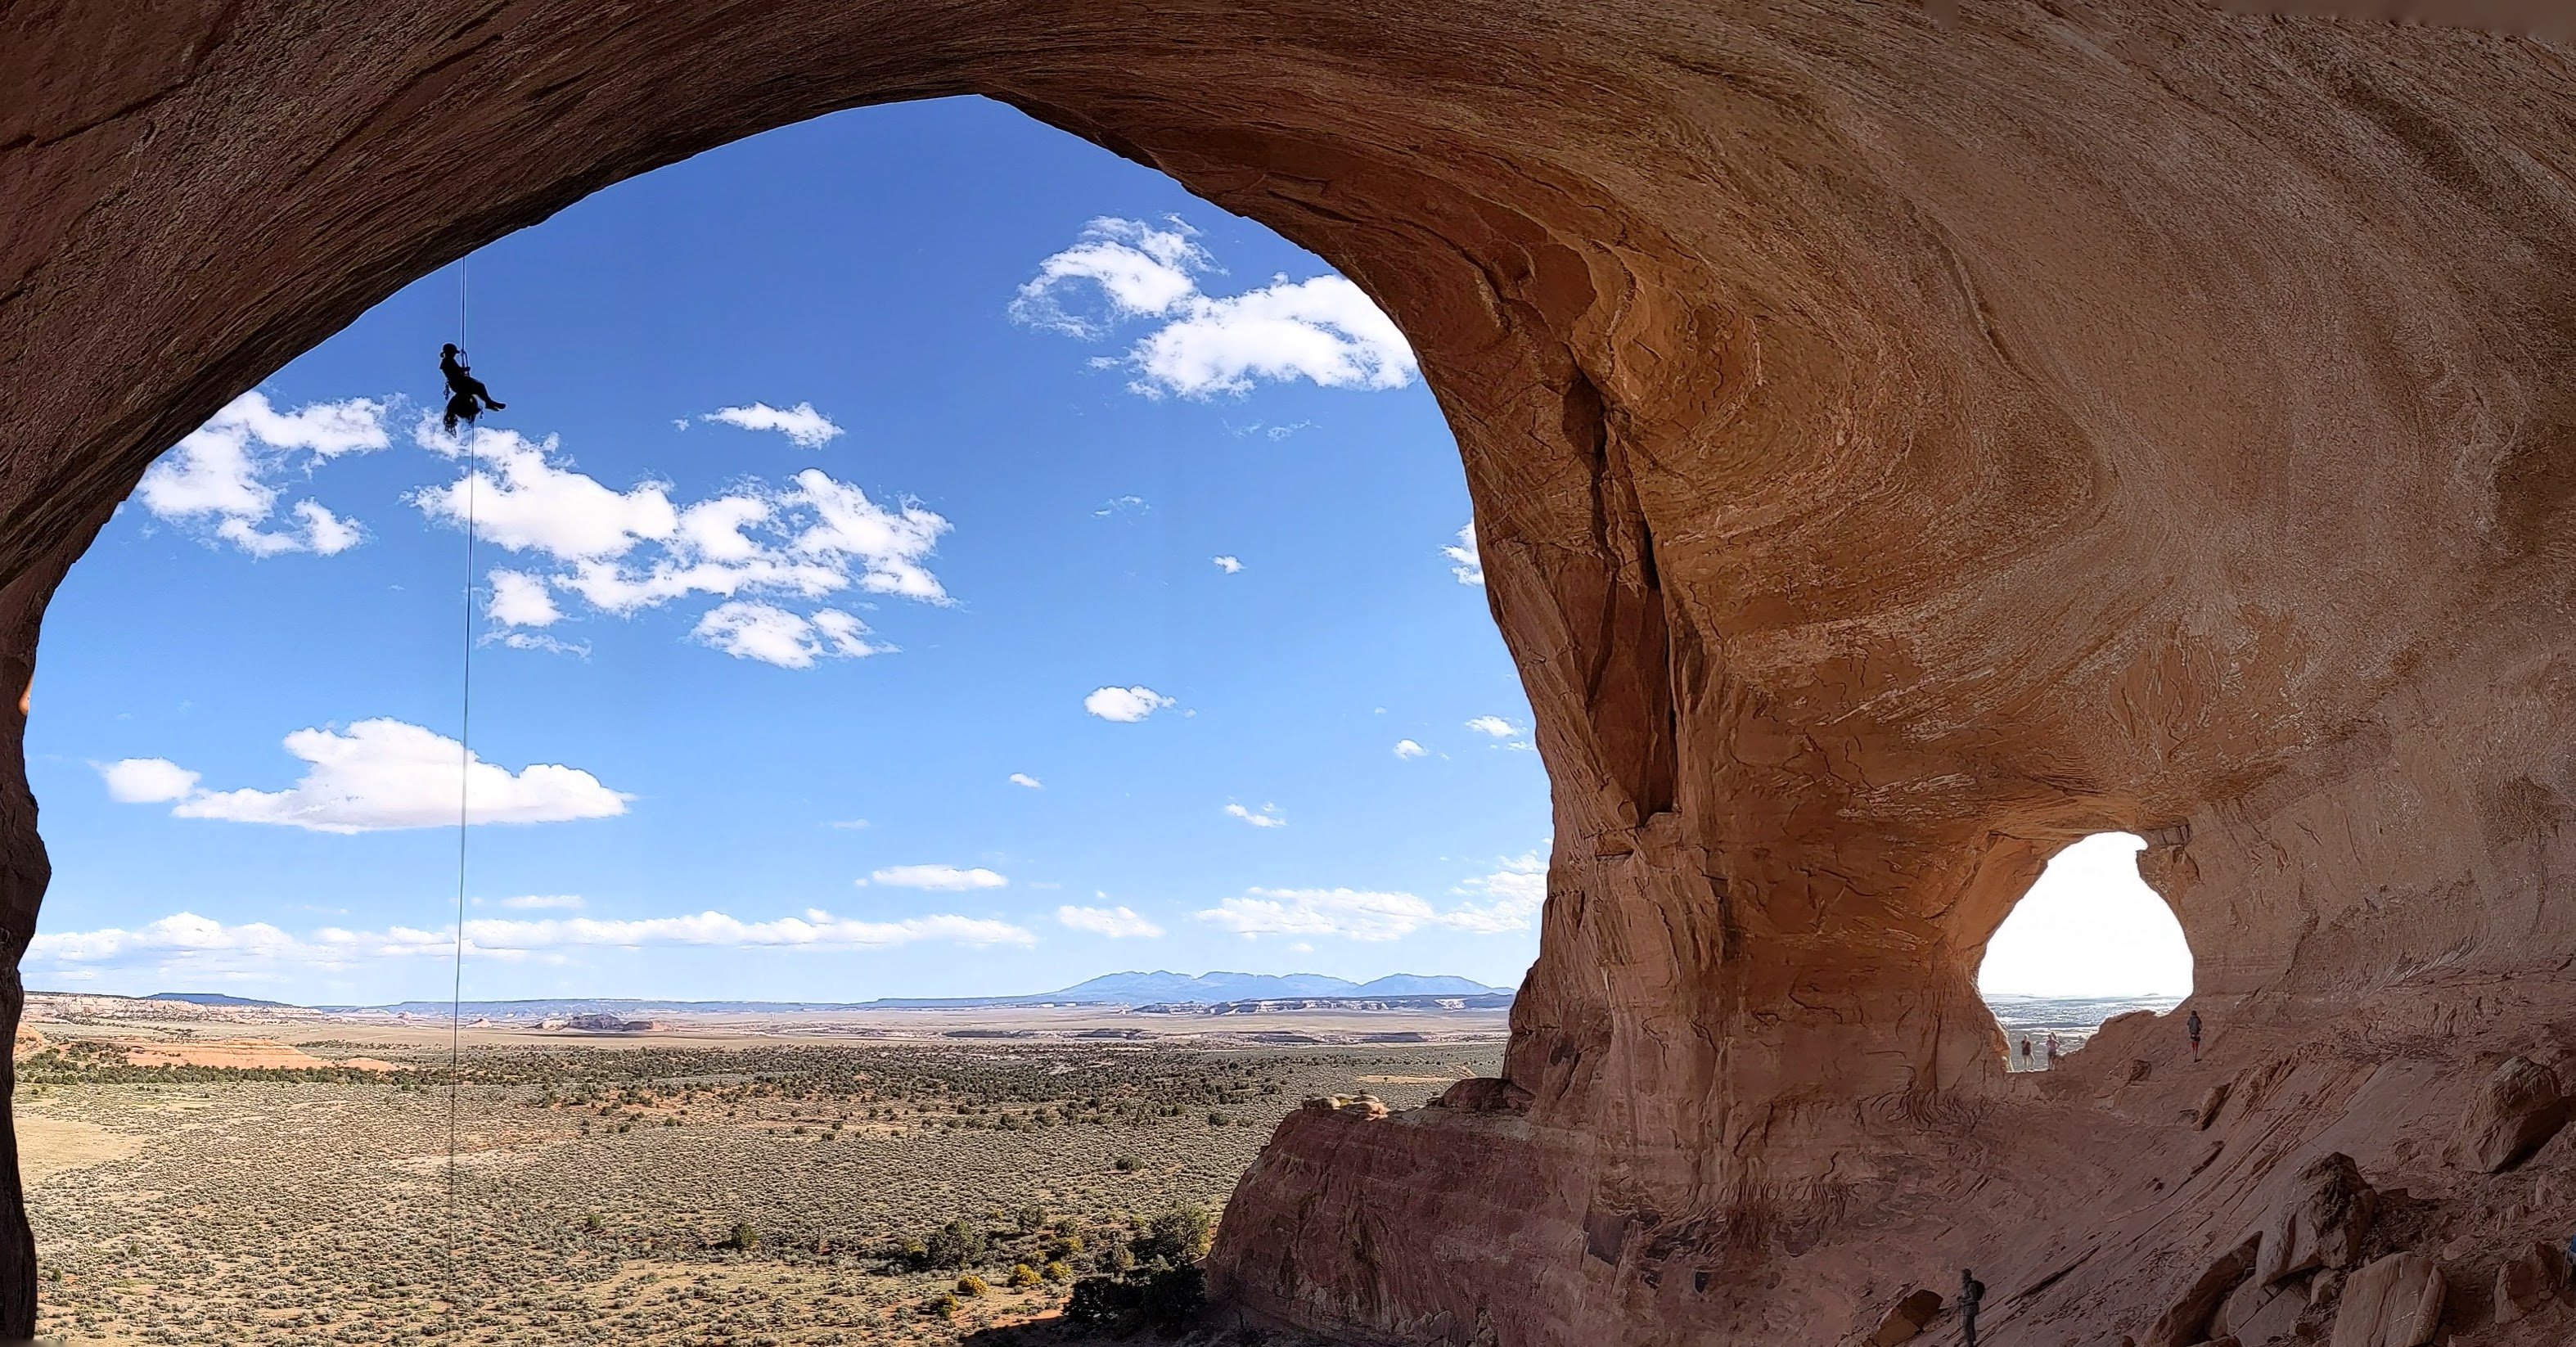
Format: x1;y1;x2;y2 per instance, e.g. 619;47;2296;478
29;101;1548;1002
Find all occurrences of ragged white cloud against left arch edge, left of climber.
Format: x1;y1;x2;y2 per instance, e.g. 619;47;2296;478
134;391;391;556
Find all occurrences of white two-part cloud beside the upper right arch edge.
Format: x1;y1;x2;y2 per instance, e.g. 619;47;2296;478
1010;216;1414;397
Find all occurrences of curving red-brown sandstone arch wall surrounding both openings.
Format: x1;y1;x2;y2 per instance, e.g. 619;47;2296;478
0;0;2576;1347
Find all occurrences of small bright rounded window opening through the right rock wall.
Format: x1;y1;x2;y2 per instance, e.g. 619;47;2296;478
1976;832;2192;1071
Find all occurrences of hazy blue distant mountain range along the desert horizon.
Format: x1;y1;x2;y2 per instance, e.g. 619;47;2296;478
146;971;1512;1020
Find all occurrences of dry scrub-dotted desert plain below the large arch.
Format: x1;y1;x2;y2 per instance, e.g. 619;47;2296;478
20;1040;1499;1347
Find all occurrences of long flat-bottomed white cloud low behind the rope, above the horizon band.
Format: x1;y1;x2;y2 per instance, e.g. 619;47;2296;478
101;719;628;832
